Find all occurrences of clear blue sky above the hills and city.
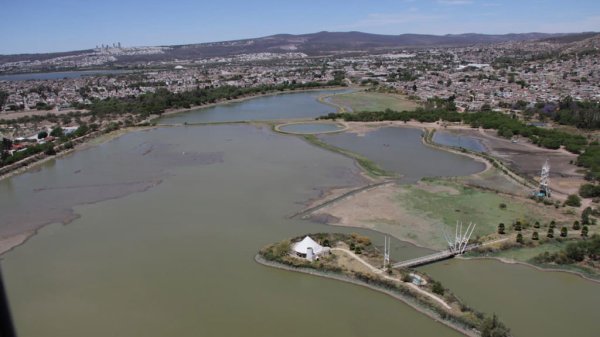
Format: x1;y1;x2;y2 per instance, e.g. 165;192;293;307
0;0;600;54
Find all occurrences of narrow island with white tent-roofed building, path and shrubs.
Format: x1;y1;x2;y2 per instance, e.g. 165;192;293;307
256;233;510;337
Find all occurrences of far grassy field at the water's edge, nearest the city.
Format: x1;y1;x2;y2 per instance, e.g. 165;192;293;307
330;91;418;112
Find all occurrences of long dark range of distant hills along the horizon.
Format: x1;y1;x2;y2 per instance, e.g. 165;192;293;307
0;32;591;64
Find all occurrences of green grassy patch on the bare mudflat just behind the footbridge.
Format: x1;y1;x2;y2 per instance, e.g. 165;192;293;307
398;180;551;236
